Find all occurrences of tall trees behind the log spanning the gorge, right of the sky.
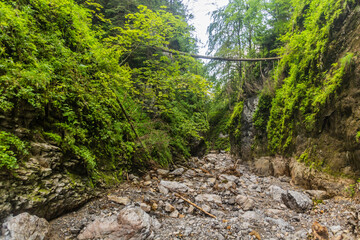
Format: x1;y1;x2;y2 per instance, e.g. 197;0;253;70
207;0;291;152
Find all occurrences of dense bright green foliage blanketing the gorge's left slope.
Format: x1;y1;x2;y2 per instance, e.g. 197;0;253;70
0;0;209;178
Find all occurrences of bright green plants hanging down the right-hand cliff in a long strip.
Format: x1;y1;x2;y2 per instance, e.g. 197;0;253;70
267;0;353;152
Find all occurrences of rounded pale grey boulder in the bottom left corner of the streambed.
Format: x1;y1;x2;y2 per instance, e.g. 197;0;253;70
0;213;49;240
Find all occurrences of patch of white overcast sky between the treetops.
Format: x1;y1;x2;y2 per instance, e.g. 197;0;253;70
183;0;228;55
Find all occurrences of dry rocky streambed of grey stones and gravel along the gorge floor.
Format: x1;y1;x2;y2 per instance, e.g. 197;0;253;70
0;153;360;240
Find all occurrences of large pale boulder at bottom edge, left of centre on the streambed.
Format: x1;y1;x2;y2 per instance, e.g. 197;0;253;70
78;206;160;240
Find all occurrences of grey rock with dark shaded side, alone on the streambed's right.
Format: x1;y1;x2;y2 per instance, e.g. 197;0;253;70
281;190;312;212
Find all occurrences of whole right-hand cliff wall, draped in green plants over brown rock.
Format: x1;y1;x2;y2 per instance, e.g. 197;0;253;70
230;1;360;194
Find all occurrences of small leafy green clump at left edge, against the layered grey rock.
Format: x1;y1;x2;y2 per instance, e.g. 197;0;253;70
0;131;28;170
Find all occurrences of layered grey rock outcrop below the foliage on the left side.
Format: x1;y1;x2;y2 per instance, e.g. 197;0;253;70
0;105;96;220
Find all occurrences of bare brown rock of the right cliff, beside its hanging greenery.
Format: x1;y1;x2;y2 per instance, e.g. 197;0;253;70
293;4;360;178
